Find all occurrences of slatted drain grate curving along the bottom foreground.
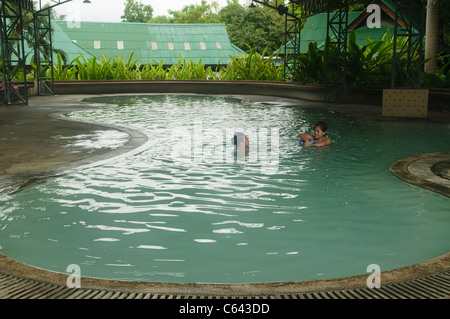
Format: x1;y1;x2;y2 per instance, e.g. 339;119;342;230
0;272;450;299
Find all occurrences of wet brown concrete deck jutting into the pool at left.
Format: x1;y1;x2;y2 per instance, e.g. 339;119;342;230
0;96;147;195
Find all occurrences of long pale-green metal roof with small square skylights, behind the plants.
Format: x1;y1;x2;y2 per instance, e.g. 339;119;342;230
53;21;245;65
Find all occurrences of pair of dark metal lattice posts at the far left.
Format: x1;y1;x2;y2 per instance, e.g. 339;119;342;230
0;0;72;105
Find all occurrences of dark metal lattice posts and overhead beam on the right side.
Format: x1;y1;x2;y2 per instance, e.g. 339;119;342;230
252;0;426;101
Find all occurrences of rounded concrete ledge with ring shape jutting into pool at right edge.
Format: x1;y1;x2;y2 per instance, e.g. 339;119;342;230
390;152;450;197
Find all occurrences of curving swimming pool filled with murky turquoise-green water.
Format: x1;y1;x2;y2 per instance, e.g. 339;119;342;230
0;95;450;283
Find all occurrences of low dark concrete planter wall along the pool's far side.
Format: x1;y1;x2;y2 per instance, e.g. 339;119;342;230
49;80;450;111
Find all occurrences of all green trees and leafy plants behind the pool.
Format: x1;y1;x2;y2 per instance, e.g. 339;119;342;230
1;0;450;87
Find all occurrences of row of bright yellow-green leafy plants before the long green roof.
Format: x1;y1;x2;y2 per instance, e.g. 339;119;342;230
48;48;284;81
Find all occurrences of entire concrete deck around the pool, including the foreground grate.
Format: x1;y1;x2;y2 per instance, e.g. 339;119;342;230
0;95;450;299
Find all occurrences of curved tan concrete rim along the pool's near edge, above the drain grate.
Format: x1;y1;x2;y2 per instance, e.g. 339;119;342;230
0;253;450;299
